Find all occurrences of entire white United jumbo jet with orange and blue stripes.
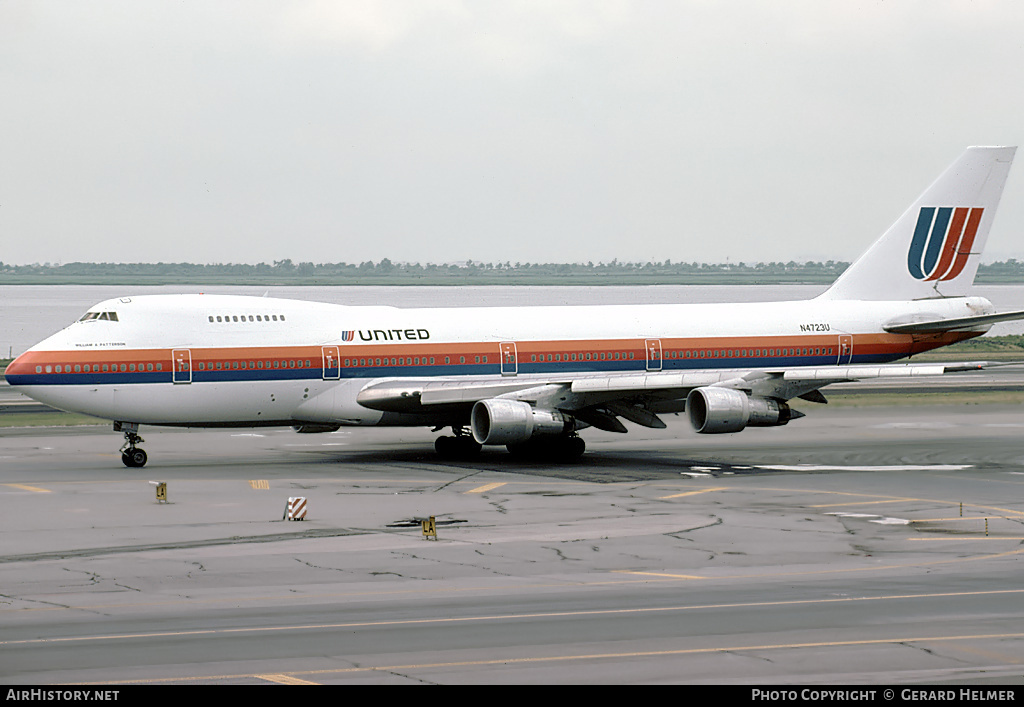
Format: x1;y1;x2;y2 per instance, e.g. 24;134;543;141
6;147;1024;468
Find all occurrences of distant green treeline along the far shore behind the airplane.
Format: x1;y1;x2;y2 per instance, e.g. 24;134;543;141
0;258;1024;285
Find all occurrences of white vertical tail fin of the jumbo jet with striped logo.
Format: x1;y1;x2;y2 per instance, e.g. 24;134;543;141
821;148;1017;300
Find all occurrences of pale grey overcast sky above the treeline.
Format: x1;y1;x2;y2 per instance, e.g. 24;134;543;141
6;0;1024;264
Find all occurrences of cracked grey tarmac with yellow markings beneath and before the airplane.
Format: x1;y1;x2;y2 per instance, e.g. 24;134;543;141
0;405;1024;684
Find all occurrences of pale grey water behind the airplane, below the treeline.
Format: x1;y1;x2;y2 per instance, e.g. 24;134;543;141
0;285;1024;358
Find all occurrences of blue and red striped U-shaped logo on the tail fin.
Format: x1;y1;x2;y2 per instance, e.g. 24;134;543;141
907;206;984;281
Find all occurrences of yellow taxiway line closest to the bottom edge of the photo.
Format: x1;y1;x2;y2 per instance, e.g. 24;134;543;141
77;633;1024;684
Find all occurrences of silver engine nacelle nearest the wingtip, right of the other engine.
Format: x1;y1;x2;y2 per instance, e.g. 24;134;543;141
686;387;803;434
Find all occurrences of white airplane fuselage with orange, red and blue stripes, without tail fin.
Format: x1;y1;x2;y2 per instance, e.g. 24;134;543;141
7;295;993;426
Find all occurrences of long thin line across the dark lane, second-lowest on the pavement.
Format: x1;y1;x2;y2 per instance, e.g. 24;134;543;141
9;586;1024;647
